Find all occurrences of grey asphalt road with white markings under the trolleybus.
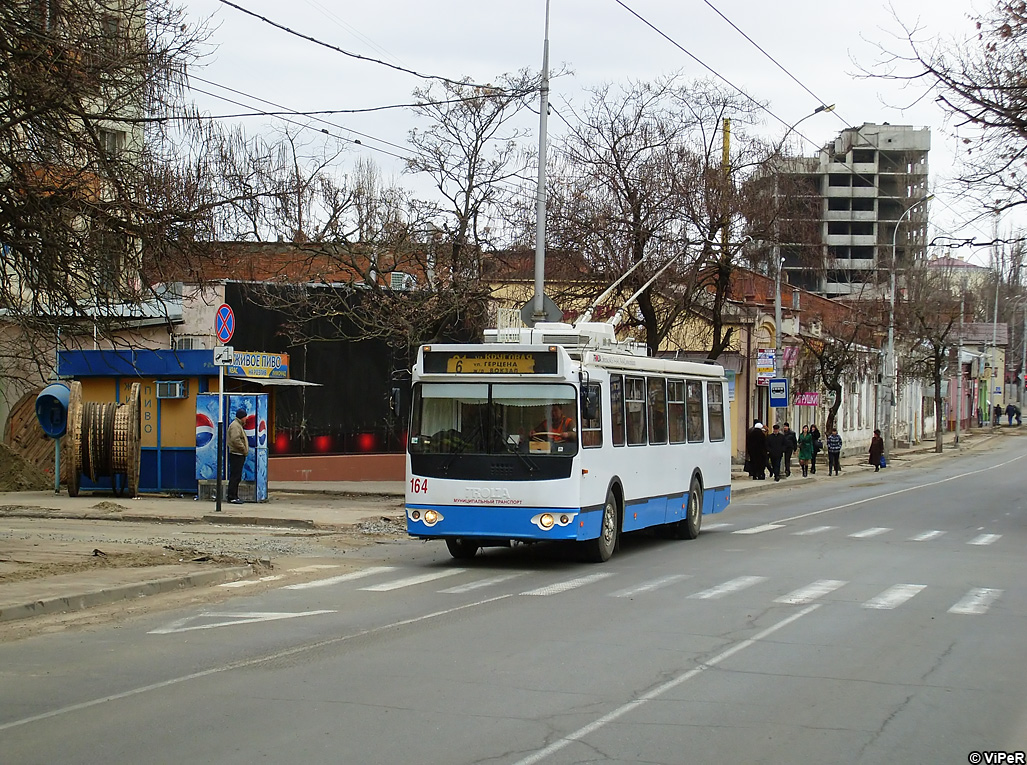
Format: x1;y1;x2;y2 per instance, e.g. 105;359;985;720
0;439;1027;764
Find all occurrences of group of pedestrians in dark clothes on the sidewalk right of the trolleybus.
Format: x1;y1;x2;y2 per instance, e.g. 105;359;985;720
745;420;884;481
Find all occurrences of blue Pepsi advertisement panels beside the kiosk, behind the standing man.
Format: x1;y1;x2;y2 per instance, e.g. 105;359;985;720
196;393;268;502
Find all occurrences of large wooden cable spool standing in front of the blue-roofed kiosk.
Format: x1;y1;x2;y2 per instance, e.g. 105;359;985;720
68;381;142;497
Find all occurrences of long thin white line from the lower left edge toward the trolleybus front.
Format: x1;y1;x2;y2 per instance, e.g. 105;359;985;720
0;594;513;732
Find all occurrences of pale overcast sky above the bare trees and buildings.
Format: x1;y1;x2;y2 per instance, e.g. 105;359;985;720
178;0;1013;261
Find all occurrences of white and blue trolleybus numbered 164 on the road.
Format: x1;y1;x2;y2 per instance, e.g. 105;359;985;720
406;322;731;562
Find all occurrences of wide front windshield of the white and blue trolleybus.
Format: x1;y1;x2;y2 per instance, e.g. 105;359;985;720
409;382;578;457
